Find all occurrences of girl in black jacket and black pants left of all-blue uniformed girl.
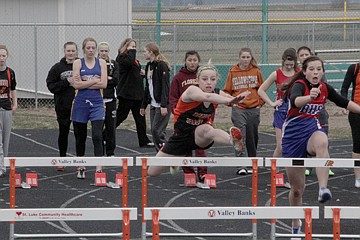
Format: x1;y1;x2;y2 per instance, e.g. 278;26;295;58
46;42;78;171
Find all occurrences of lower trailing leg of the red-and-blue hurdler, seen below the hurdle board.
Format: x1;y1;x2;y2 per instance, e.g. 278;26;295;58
286;167;305;227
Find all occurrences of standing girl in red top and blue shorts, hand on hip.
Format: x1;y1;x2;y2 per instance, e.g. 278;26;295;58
258;48;299;157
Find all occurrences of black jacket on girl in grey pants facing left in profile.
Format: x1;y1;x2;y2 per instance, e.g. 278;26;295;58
142;61;170;108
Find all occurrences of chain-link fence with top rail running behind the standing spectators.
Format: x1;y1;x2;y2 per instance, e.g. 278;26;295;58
0;21;360;107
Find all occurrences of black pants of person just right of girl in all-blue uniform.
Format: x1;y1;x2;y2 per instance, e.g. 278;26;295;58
103;99;116;156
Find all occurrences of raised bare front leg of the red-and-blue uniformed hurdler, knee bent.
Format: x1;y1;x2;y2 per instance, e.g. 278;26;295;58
307;131;330;188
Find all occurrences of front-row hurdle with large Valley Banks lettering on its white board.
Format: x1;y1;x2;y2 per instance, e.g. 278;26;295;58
144;207;319;240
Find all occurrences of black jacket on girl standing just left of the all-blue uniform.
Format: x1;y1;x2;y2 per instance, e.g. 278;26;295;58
46;58;75;111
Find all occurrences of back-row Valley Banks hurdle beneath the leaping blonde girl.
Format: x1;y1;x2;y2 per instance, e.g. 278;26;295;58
136;157;263;240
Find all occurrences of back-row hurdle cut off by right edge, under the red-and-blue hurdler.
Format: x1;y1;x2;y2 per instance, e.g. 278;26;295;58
265;158;360;239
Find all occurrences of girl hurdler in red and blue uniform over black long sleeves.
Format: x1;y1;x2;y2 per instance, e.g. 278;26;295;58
282;56;360;234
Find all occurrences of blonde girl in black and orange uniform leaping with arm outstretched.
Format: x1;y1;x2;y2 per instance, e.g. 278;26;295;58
148;61;250;176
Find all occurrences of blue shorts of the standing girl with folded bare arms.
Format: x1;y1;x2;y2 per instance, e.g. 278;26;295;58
71;97;105;123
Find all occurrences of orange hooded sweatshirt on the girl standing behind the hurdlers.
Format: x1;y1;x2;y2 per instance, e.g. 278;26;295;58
223;64;264;108
